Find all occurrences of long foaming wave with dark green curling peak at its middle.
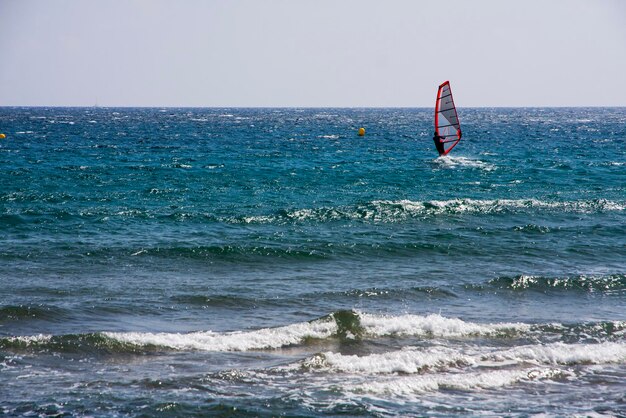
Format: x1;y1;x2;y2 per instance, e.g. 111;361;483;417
0;311;530;352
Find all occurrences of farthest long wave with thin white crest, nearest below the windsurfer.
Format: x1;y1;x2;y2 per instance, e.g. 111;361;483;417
0;198;626;232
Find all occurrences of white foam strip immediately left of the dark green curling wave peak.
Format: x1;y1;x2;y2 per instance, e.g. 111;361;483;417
103;319;337;351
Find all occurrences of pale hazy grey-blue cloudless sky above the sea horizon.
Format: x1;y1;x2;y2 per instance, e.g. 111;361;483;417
0;0;626;107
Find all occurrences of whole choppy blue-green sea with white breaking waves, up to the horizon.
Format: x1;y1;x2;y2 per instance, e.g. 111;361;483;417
0;107;626;417
